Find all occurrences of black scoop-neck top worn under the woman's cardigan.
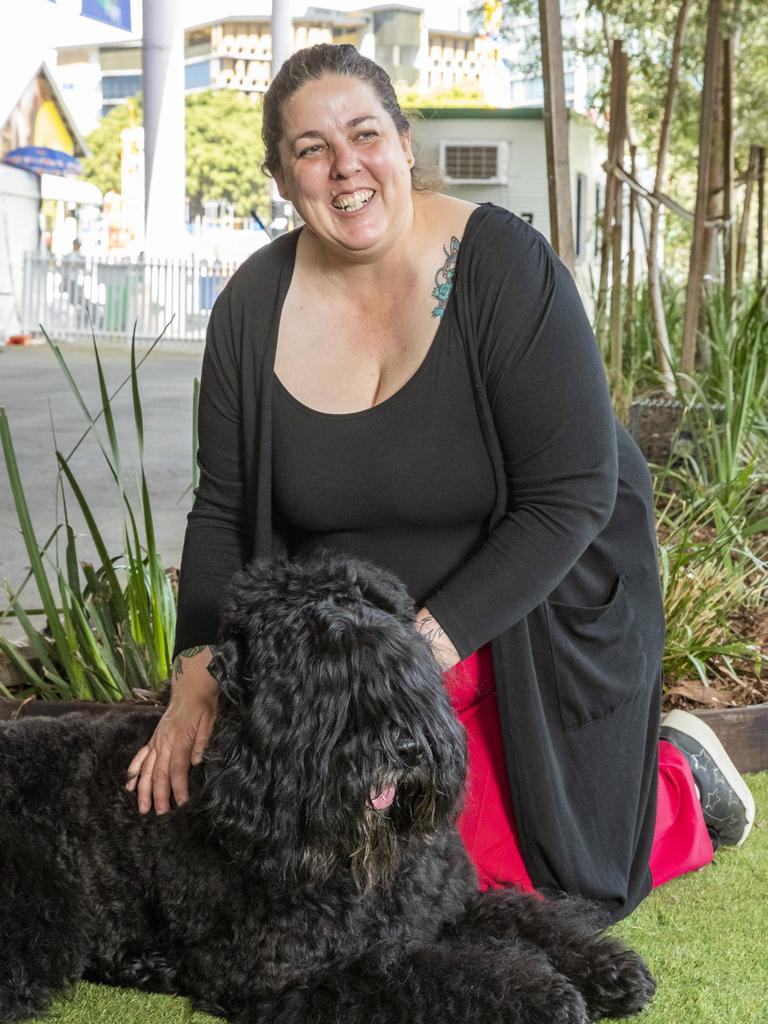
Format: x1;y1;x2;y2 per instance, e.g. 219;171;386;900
272;303;496;607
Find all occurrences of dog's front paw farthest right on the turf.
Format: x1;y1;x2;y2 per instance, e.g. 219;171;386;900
585;944;656;1020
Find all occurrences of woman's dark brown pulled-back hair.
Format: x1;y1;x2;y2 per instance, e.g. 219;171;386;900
261;43;438;189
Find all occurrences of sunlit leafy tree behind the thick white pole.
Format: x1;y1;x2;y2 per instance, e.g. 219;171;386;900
83;90;269;217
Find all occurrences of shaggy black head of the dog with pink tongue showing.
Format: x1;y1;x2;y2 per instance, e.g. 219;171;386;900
196;552;466;888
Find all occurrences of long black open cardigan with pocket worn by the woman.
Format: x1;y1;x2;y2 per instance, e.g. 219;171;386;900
175;205;664;920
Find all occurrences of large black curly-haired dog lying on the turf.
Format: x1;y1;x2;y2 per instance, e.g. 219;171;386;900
0;554;654;1024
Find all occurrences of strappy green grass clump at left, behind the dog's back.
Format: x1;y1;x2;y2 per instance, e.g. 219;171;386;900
0;332;183;701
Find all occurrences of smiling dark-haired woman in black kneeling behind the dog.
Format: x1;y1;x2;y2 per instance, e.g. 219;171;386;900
128;45;746;919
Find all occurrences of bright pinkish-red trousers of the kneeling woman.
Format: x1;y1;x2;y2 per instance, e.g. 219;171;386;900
445;646;714;892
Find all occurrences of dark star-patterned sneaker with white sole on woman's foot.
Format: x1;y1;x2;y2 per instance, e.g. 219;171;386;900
660;711;755;846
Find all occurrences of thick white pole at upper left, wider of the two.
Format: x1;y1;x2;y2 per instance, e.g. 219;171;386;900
142;0;186;255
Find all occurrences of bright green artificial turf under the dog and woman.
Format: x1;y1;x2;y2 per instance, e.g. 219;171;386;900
20;772;768;1024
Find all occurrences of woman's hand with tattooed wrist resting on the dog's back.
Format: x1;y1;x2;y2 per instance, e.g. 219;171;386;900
126;646;218;814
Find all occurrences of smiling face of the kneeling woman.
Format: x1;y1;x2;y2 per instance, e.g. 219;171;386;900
275;75;413;255
